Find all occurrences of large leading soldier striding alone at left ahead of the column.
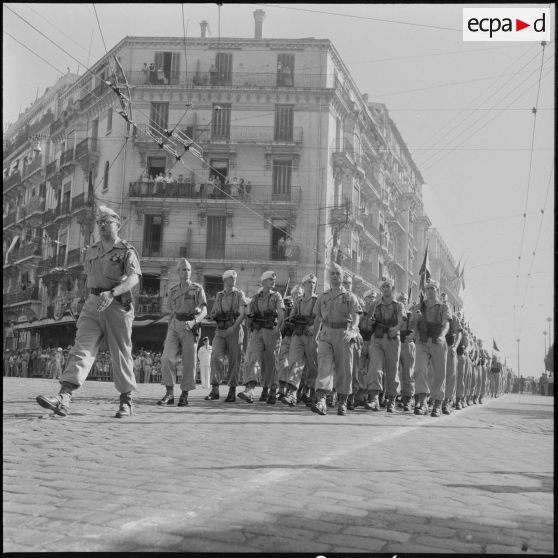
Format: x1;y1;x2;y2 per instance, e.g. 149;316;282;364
37;206;141;418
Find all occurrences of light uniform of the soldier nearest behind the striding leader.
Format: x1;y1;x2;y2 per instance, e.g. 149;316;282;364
161;283;207;392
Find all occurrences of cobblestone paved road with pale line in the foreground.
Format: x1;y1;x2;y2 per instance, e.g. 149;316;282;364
3;378;554;554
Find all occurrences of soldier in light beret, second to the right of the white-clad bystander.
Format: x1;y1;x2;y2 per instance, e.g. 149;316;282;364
238;271;285;405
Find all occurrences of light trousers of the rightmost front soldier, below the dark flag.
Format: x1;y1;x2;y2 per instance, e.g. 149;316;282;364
415;339;448;401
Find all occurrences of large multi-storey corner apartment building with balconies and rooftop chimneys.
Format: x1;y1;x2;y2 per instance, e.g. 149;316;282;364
4;10;462;350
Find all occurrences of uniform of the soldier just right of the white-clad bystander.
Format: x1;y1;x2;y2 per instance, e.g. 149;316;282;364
211;287;246;394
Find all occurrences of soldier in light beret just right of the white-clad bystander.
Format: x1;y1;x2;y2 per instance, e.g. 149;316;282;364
206;269;247;403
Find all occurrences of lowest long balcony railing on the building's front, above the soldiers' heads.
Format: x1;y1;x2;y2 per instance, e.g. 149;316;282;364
129;240;299;262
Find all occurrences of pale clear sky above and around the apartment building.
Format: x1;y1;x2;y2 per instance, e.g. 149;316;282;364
3;3;556;377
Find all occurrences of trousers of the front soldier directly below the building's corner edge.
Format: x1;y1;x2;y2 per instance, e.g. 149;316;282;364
316;326;353;395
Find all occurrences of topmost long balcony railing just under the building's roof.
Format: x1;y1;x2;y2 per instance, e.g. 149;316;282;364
122;70;326;89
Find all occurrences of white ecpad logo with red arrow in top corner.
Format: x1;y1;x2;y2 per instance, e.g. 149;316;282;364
463;7;551;41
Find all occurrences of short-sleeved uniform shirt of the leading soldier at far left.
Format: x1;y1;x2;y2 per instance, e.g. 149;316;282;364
85;240;141;290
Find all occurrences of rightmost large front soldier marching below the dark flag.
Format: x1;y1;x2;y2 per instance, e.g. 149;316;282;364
411;280;451;417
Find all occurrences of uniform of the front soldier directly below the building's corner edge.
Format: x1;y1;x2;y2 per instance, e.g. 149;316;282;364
313;287;362;409
